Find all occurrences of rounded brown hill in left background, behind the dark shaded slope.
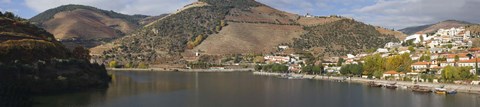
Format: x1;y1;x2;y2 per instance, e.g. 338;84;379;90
30;5;147;47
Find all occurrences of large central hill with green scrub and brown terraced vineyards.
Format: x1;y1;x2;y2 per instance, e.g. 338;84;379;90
92;0;404;64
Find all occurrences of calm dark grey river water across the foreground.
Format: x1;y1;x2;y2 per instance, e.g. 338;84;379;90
33;72;480;107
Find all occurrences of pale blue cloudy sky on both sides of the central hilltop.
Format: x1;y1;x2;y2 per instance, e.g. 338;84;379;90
0;0;480;29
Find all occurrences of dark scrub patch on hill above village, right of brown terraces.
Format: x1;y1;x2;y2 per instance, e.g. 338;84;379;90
293;19;399;56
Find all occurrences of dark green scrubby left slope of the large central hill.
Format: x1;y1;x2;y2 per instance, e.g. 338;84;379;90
103;1;239;63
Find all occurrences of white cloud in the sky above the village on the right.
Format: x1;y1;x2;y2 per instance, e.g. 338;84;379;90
352;0;480;29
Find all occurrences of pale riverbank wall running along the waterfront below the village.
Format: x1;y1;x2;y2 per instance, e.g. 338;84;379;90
253;72;480;94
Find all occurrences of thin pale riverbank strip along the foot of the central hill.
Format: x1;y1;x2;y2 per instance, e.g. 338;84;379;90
107;68;255;72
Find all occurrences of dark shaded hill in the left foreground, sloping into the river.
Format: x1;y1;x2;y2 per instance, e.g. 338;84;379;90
0;12;110;101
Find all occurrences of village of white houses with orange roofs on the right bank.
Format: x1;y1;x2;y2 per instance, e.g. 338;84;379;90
257;27;480;85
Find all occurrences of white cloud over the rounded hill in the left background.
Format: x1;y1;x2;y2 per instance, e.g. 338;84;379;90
25;0;196;15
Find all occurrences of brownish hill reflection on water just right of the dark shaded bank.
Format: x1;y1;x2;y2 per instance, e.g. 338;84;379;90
107;72;188;98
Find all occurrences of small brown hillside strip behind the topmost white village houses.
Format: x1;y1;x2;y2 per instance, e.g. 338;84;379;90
399;20;472;35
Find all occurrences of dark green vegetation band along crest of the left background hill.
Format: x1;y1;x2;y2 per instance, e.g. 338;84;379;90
30;4;148;25
